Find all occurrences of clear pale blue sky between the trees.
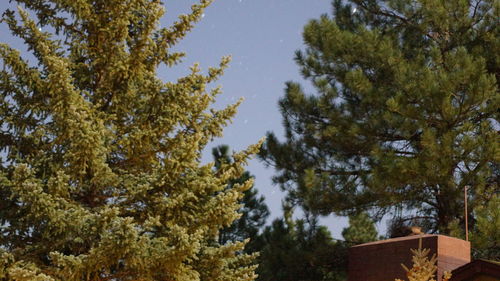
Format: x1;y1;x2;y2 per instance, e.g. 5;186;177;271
0;0;384;239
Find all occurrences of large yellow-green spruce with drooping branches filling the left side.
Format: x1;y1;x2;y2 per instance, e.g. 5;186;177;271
0;0;257;281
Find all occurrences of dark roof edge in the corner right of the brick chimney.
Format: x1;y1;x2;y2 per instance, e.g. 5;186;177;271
451;260;500;281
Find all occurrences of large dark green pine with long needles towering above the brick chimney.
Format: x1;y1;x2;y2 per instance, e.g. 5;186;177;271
261;0;500;234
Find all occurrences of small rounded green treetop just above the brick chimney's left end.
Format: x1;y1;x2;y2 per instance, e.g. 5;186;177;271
342;213;378;245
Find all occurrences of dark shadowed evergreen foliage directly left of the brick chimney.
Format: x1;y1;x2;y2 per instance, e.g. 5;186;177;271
257;216;347;281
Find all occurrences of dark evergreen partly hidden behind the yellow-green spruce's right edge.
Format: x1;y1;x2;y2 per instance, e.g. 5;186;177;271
212;145;269;253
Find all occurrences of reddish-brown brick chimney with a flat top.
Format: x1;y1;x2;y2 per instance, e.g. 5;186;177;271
348;234;470;281
